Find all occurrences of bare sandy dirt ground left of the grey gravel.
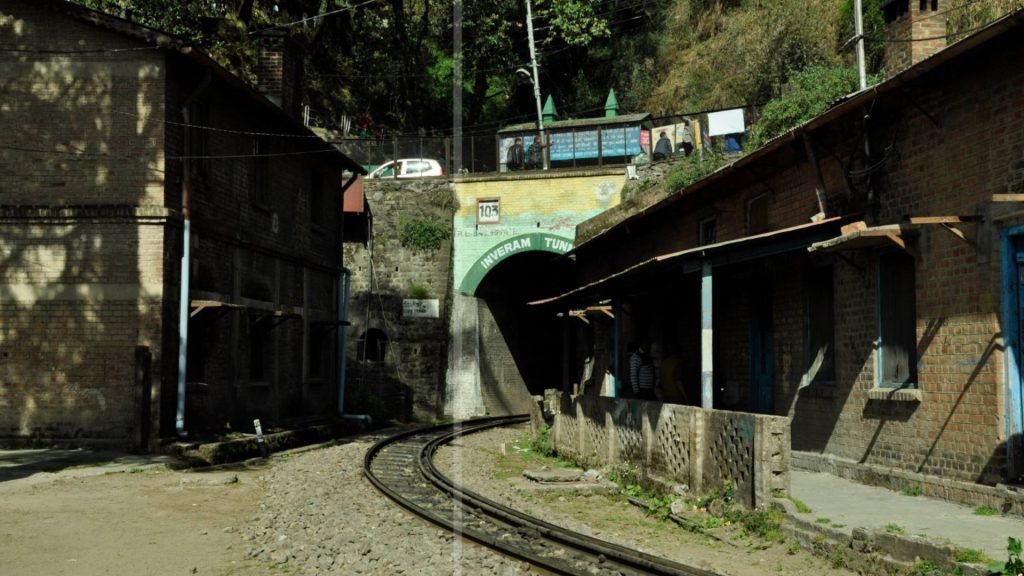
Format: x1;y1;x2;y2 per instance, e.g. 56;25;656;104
0;466;272;576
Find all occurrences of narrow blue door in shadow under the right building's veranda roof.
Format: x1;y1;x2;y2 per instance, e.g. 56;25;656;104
750;277;775;414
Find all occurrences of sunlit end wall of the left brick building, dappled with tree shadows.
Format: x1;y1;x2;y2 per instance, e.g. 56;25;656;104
0;2;167;446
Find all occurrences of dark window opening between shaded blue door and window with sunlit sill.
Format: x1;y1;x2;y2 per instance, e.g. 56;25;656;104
805;266;836;385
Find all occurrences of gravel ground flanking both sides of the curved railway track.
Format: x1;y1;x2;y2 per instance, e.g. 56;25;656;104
241;427;853;576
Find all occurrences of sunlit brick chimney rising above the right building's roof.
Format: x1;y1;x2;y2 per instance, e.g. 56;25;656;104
882;0;948;77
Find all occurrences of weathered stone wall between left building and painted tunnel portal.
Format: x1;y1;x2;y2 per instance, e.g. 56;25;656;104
345;178;454;420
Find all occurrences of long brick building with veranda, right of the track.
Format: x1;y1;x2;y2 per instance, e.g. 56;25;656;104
535;0;1024;500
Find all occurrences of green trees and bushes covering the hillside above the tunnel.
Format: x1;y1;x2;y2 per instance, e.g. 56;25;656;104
74;0;1020;138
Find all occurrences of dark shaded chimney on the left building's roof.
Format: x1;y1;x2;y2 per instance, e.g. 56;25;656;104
256;30;302;118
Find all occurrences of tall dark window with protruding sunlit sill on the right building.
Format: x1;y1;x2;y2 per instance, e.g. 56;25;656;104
878;250;918;387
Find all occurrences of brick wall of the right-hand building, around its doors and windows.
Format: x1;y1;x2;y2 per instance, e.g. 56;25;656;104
577;30;1024;483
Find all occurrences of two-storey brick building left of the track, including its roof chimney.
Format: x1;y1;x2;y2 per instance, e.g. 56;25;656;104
0;0;361;447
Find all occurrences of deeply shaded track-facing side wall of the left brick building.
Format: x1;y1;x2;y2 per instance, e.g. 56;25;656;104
165;51;341;431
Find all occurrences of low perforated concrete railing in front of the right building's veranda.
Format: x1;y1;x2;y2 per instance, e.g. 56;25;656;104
552;389;790;506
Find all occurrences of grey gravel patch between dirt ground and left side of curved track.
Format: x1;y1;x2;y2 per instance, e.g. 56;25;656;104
242;432;536;576
